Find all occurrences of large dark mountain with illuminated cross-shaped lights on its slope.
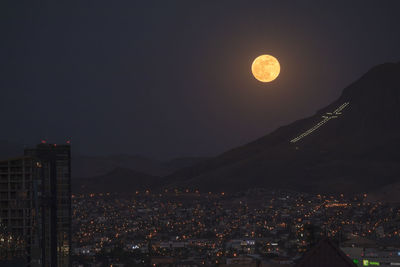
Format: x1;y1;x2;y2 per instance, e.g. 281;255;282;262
164;63;400;192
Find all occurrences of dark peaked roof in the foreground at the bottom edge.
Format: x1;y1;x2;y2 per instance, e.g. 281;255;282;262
295;239;357;267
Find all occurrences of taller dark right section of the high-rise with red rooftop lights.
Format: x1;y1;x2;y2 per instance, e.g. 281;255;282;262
25;143;71;267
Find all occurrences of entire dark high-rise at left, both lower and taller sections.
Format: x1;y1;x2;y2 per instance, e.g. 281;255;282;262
0;144;71;267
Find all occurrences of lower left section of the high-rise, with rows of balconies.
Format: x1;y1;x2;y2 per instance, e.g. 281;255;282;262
0;157;40;266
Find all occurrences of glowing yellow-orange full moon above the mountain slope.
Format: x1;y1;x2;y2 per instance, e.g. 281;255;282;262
251;55;281;83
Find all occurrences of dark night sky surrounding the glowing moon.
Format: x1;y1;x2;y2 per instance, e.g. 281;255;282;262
0;0;400;158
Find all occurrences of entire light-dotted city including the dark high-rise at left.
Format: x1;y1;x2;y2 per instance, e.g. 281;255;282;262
0;142;400;266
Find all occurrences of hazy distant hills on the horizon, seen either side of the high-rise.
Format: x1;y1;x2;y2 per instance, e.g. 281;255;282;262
0;140;206;192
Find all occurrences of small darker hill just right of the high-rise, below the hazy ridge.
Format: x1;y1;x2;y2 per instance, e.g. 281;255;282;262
72;168;160;193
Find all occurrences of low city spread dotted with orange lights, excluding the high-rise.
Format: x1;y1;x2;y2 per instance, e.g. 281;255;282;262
72;192;400;266
